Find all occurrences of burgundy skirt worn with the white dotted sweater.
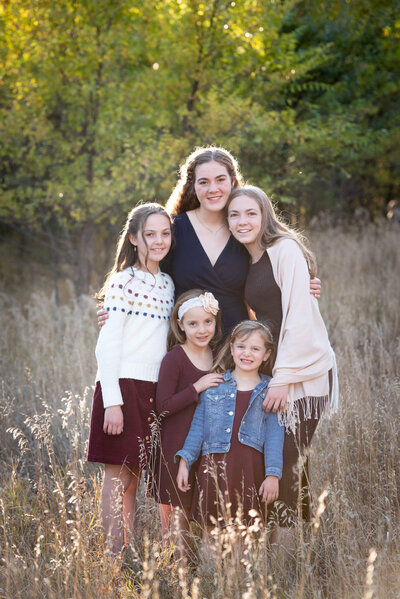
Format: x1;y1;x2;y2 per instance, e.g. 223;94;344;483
87;379;156;469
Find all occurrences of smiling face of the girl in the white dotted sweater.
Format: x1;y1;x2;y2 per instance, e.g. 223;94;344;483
129;214;172;271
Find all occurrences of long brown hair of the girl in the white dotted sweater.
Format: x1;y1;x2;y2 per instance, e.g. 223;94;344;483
95;202;171;304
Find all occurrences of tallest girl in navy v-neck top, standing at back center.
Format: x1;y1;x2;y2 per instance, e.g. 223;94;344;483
166;147;249;336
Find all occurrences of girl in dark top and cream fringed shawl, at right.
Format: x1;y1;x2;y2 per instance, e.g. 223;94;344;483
227;186;337;544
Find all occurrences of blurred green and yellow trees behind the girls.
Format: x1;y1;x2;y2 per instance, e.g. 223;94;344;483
0;0;400;295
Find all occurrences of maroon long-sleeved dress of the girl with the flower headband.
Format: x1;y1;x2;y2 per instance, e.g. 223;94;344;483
150;346;208;508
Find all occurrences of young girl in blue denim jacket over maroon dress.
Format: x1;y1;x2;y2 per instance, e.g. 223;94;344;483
176;320;284;526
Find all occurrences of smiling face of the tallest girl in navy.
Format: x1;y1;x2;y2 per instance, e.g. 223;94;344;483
194;160;232;212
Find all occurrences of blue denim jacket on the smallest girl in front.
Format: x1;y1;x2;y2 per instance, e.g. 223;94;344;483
175;370;285;478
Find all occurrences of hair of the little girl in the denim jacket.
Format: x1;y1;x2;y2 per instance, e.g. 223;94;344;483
211;320;274;374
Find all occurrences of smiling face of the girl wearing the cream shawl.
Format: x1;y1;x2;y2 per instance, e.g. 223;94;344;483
228;195;262;249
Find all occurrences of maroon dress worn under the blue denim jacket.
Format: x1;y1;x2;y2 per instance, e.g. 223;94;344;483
191;390;265;526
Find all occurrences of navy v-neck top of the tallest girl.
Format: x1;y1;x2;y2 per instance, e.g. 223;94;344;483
162;212;249;337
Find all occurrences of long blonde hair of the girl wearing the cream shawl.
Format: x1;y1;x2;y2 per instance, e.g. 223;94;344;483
225;185;317;278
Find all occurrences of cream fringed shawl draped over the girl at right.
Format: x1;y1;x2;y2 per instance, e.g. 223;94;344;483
266;238;338;431
